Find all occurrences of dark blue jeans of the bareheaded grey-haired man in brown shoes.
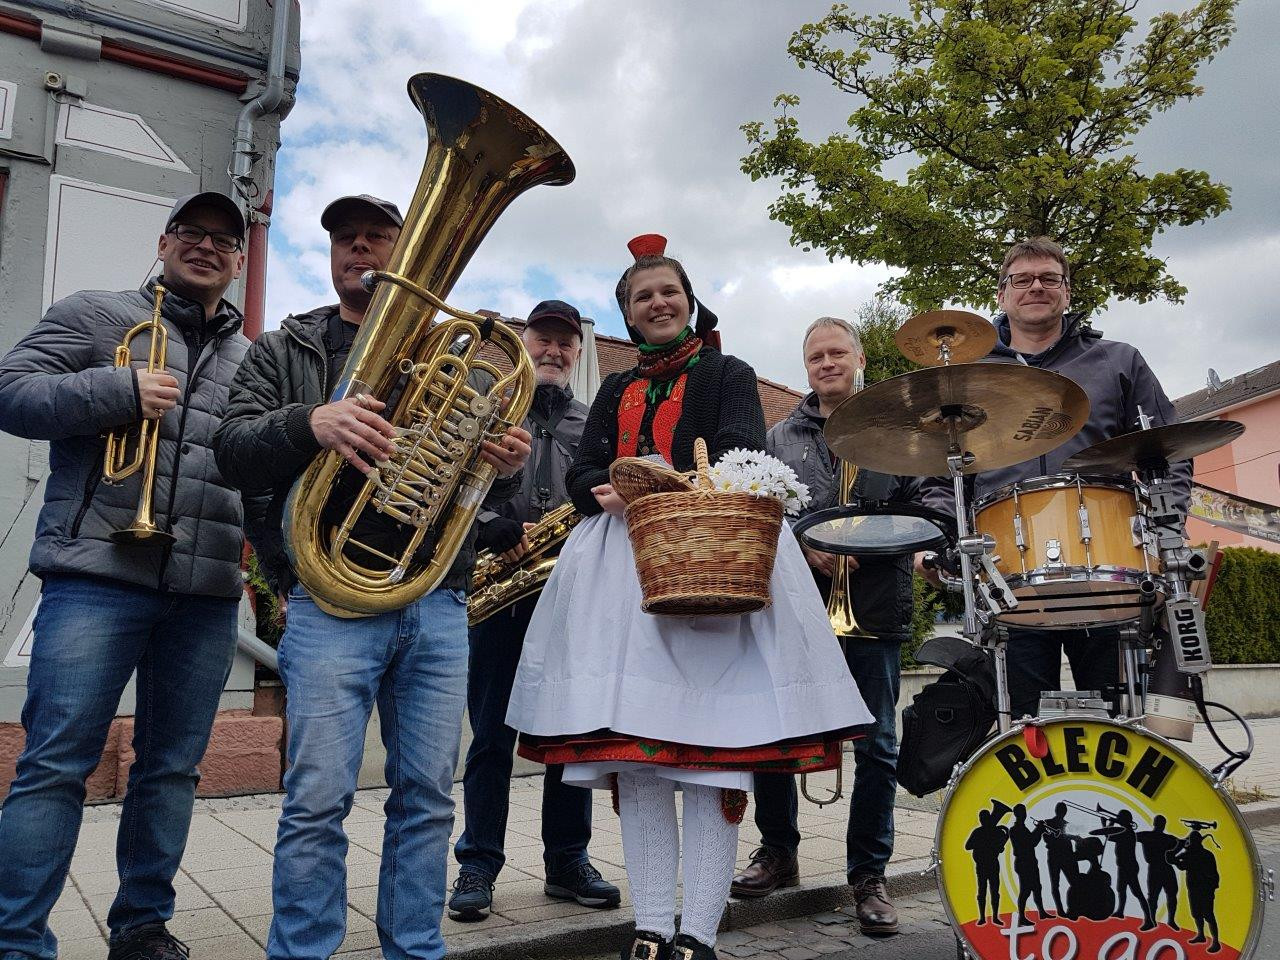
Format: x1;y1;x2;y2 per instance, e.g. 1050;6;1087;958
755;639;902;881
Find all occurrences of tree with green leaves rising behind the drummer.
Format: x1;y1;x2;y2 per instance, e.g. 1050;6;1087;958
742;0;1236;310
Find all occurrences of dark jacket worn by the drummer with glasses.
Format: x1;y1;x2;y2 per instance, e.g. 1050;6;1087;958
924;314;1192;516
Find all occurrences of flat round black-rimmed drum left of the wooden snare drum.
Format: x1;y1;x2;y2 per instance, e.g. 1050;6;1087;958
792;503;950;557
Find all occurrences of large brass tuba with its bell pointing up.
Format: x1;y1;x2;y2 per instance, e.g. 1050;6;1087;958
284;73;573;616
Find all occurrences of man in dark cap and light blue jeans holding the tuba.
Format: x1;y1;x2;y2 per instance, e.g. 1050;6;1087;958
215;195;530;960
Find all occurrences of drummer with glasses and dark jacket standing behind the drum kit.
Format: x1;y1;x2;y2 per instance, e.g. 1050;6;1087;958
918;237;1192;719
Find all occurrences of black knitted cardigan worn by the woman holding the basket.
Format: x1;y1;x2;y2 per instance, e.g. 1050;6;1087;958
566;347;764;516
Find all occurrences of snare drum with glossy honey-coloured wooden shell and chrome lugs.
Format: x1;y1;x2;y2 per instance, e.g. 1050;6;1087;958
973;474;1164;628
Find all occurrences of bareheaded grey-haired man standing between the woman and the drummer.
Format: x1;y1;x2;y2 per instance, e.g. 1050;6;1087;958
732;316;919;934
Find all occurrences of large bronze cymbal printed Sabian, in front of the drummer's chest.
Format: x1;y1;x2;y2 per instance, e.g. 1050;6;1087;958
823;364;1089;476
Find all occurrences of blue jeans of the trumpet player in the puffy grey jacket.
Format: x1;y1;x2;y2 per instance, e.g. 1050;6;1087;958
0;575;237;960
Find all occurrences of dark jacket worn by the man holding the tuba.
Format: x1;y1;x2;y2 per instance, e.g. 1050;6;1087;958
214;305;520;591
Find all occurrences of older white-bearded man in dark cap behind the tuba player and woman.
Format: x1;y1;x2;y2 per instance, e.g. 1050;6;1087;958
449;300;622;920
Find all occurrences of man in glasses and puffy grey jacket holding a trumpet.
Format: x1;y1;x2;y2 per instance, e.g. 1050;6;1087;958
0;193;248;960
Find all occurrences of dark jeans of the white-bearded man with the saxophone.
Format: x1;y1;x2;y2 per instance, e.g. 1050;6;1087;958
453;596;591;883
